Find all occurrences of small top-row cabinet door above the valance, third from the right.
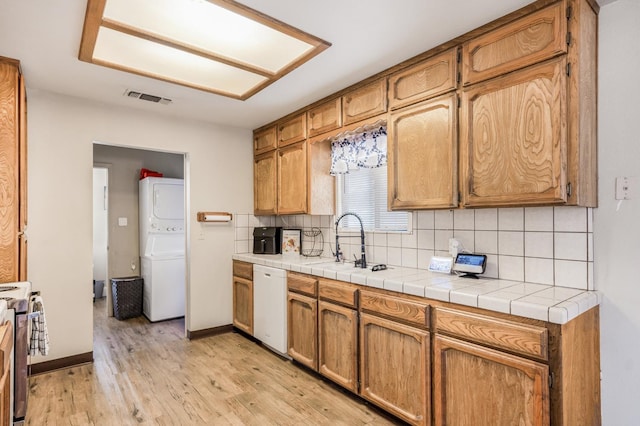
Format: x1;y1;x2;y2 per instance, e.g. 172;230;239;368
342;78;387;126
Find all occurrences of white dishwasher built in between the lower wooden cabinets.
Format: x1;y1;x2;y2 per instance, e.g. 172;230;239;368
253;264;287;356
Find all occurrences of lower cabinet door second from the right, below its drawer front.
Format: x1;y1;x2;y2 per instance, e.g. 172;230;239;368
360;313;430;425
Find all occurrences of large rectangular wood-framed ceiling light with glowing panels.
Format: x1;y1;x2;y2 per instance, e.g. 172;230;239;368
78;0;330;100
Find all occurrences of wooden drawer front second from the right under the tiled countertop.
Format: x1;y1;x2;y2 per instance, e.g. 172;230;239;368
360;290;429;328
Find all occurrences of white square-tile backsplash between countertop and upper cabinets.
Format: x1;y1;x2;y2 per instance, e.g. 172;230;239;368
234;207;594;290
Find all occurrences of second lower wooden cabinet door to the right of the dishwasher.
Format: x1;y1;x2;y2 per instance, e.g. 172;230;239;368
318;301;358;393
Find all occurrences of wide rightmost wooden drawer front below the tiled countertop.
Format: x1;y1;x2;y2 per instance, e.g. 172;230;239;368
434;308;549;360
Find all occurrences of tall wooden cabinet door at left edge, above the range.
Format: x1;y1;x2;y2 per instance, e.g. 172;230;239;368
0;59;21;283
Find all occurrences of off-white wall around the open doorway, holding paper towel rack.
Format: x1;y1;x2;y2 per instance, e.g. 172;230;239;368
28;90;253;363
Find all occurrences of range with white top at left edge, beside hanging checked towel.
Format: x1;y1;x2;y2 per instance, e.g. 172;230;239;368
0;281;31;425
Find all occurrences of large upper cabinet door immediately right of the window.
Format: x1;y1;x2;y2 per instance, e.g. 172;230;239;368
388;93;458;210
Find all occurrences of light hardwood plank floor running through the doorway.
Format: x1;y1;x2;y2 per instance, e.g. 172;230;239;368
26;299;399;426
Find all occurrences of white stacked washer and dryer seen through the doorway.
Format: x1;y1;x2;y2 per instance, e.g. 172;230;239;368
139;177;186;322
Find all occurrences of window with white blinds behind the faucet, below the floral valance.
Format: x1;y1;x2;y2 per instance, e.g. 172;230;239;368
336;164;411;232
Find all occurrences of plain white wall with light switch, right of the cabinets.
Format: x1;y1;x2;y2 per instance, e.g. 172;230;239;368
594;0;640;426
